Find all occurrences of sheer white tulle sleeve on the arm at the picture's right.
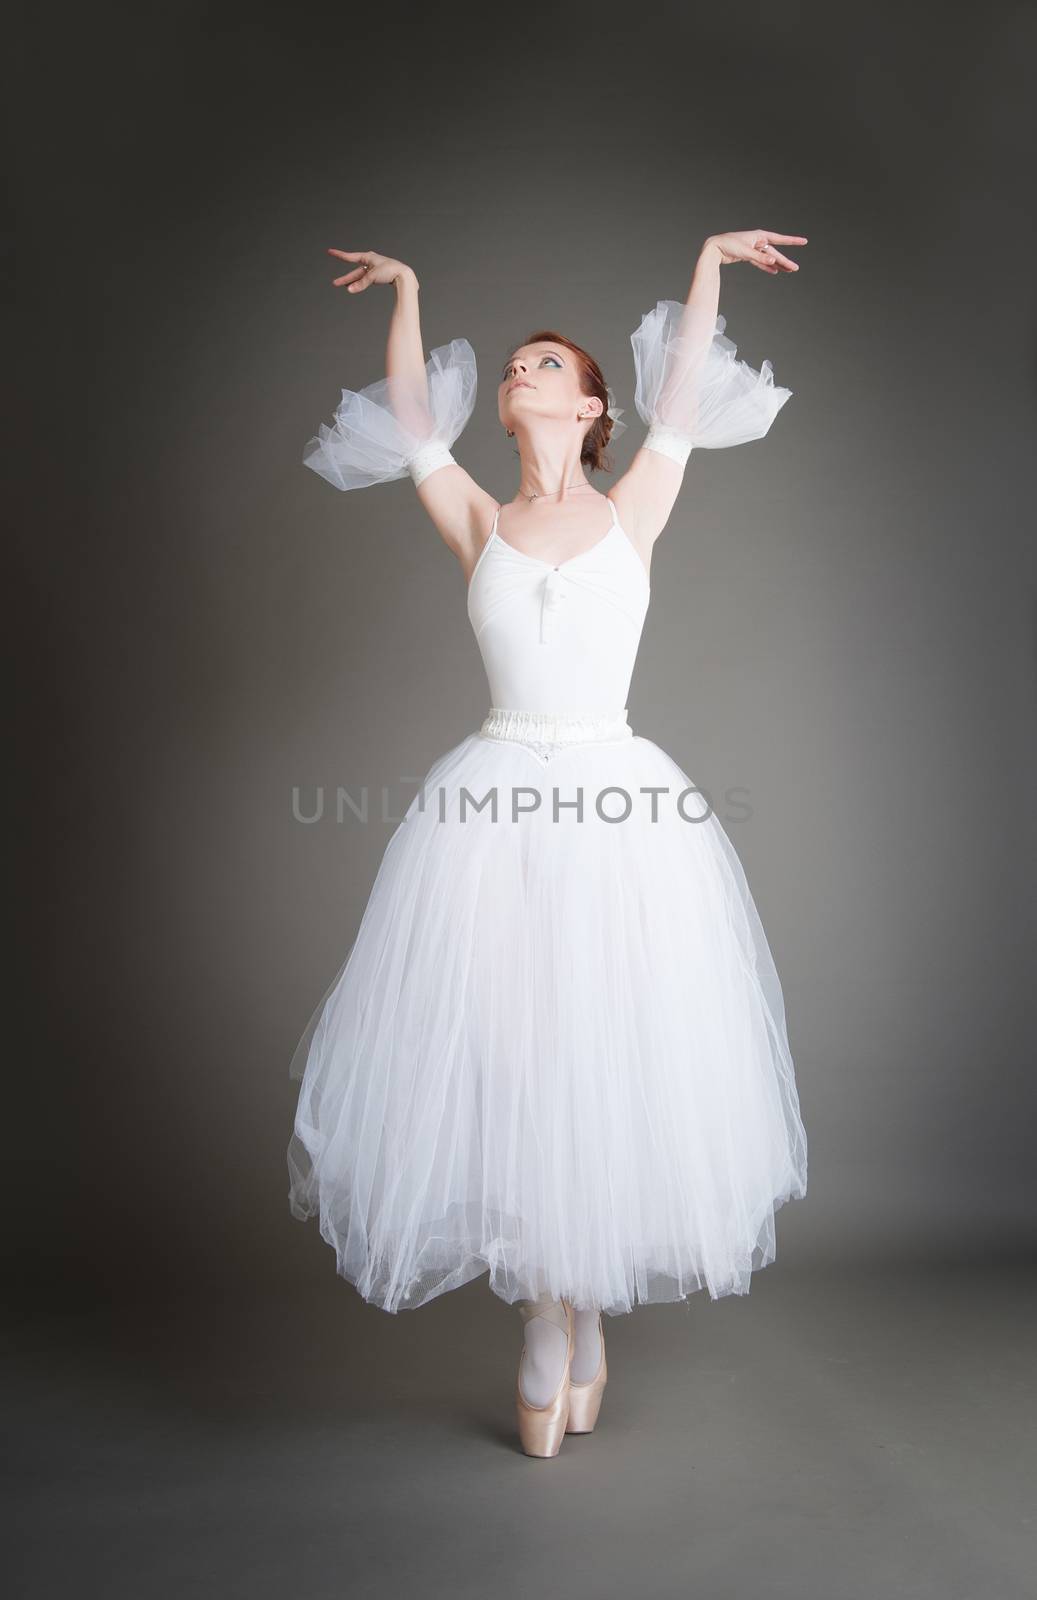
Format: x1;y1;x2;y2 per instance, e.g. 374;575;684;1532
631;301;792;464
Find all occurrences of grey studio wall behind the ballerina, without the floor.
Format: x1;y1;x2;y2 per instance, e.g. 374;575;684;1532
8;5;1037;1299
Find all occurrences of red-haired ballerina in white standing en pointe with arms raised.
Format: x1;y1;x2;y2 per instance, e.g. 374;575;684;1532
288;229;807;1456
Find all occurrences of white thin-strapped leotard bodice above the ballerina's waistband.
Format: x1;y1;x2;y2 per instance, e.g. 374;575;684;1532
467;499;650;715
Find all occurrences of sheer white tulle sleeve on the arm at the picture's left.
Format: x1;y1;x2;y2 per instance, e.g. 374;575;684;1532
302;339;477;490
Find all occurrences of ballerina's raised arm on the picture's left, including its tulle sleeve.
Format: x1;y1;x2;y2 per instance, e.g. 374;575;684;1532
302;250;496;582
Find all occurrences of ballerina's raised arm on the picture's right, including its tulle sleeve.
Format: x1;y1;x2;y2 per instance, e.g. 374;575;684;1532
611;229;807;563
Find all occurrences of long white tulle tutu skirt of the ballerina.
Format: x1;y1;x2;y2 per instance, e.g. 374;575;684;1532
288;733;807;1315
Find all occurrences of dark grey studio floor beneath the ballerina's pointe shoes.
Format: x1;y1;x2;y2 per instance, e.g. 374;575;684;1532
5;1261;1037;1600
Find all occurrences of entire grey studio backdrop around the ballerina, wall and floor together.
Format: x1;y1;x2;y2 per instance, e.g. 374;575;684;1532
3;0;1037;1600
